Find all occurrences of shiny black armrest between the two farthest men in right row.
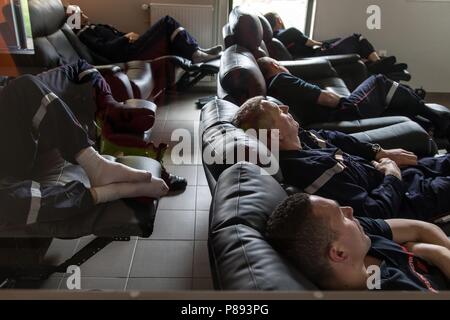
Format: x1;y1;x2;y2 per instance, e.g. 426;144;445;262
280;58;337;79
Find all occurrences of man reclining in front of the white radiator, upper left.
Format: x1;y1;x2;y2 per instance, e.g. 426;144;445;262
69;6;222;63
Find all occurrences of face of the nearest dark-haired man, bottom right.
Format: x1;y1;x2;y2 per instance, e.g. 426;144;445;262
311;196;371;261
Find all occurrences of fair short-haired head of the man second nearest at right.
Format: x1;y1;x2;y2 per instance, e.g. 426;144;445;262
232;96;300;150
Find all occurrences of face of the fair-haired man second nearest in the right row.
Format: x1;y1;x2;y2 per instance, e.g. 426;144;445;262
262;100;300;147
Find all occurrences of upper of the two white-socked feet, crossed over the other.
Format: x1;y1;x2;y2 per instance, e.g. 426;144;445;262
76;147;152;187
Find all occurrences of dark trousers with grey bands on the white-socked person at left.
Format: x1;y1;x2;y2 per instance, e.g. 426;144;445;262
0;75;94;228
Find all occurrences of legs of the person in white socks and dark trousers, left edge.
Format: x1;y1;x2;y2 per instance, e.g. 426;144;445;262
0;75;168;228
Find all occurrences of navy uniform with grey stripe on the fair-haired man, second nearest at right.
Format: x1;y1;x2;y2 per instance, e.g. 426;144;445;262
280;130;450;221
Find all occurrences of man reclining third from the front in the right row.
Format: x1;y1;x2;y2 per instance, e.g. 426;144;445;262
258;57;450;137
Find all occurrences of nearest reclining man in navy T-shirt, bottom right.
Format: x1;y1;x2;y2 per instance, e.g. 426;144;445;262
267;193;450;292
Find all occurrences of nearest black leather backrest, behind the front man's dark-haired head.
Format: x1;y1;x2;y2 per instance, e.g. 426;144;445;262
208;163;316;290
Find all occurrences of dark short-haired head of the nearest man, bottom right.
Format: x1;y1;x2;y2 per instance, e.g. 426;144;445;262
267;193;371;289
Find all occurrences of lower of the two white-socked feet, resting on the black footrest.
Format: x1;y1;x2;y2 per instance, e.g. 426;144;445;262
92;178;169;204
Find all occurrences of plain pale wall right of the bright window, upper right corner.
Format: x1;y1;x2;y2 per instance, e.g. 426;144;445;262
314;0;450;92
